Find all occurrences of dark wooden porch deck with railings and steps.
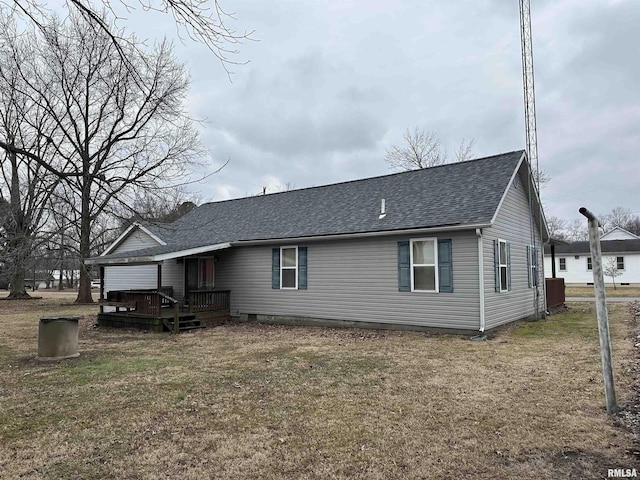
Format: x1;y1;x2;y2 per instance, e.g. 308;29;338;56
98;290;230;332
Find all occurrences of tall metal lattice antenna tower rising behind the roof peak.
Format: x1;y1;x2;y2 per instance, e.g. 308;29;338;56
520;0;540;192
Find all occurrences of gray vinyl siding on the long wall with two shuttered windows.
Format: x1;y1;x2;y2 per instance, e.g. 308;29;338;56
216;232;480;331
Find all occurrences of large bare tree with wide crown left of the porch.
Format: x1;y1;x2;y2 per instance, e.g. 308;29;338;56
0;14;203;303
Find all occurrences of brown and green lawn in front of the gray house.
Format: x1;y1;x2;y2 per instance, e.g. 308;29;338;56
0;298;638;479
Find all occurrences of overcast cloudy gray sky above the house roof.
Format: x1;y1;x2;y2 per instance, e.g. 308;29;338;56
123;0;640;224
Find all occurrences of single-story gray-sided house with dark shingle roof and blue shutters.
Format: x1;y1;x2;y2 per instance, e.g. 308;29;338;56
87;151;548;332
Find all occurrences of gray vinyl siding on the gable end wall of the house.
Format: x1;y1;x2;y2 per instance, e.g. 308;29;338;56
483;169;545;330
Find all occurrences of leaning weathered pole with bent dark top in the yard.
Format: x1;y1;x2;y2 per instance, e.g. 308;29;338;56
580;207;618;414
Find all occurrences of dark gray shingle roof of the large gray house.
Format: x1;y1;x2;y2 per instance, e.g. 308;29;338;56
104;150;524;257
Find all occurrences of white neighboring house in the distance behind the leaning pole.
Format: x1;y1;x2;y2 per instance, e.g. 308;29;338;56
544;227;640;285
